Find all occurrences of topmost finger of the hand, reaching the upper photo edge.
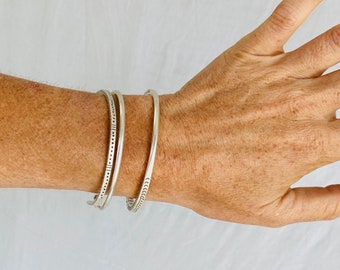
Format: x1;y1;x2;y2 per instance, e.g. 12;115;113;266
238;0;322;55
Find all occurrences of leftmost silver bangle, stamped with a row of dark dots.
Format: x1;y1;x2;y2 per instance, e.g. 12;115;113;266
87;90;117;208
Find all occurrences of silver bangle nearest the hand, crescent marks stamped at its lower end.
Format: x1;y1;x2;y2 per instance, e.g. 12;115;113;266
126;90;159;212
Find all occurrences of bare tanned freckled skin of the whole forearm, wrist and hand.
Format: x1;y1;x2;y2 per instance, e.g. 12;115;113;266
0;0;340;227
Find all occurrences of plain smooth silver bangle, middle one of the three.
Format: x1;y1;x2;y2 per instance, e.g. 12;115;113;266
99;91;125;209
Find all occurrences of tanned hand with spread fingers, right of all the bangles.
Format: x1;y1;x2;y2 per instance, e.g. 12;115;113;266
156;0;340;227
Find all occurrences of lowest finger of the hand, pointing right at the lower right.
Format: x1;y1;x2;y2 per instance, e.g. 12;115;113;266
278;185;340;225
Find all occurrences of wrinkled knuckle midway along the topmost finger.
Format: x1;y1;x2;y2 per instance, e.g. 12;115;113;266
270;3;297;30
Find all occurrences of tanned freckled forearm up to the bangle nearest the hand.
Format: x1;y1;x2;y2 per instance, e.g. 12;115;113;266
0;75;167;199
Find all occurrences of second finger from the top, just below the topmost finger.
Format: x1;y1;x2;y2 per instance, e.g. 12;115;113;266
283;24;340;78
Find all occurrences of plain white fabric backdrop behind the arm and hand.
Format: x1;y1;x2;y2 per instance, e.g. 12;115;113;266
0;0;340;270
